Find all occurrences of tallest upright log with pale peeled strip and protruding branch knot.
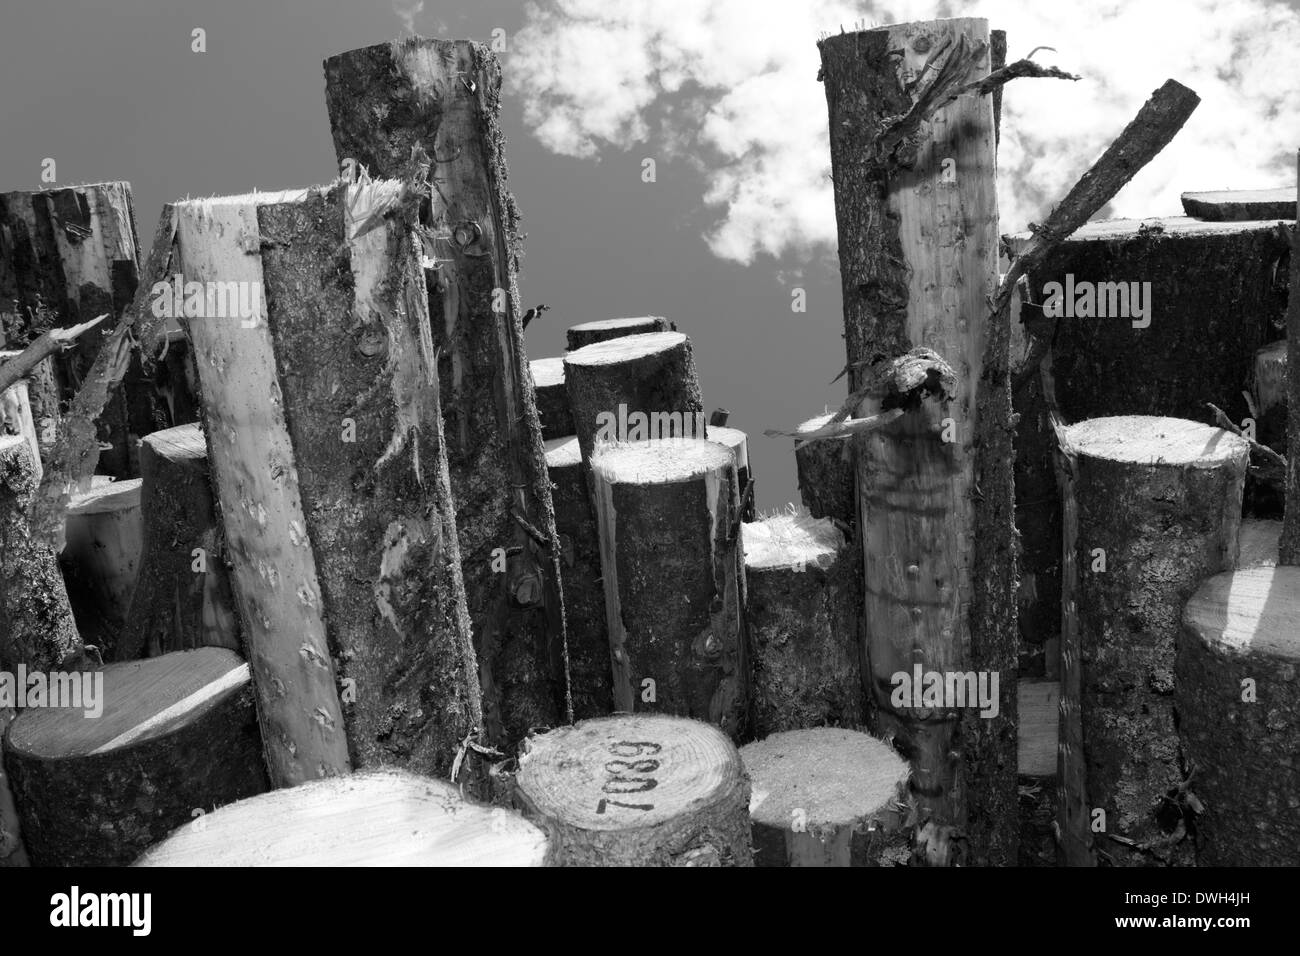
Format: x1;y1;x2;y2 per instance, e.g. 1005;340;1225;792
819;20;1017;864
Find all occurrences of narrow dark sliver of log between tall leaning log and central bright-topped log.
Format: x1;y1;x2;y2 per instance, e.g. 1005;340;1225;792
546;434;614;721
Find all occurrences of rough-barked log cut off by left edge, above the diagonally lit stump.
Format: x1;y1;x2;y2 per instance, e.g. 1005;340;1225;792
0;434;82;670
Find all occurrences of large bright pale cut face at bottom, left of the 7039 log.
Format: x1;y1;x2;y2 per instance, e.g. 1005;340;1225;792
135;770;550;866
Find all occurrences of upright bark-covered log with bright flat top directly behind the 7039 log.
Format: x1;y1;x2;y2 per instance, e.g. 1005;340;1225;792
588;437;749;739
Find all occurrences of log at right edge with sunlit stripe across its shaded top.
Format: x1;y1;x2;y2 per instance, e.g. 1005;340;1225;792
1174;567;1300;866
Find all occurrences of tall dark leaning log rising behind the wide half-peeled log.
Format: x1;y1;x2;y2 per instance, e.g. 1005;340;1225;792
325;38;567;741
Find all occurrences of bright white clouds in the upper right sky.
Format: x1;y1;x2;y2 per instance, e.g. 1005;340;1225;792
507;0;1300;263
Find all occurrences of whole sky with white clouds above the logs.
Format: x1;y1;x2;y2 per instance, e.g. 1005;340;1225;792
0;0;1300;511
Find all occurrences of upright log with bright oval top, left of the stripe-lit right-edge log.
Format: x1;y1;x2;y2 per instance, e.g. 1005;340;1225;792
1065;415;1249;866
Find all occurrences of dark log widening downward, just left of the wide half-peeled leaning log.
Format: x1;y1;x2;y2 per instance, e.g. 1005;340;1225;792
117;424;241;661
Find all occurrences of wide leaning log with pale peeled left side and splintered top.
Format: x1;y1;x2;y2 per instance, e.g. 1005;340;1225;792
176;181;482;786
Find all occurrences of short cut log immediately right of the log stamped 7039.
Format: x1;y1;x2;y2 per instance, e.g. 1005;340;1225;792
740;727;910;866
